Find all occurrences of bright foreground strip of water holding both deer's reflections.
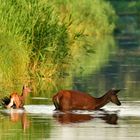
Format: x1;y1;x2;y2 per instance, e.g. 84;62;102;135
0;101;140;140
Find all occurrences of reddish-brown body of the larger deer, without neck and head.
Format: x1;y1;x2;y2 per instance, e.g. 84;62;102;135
53;90;96;110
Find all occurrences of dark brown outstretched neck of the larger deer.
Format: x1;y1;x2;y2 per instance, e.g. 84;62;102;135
96;93;110;109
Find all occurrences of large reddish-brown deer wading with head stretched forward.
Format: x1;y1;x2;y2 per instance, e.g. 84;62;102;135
53;89;121;111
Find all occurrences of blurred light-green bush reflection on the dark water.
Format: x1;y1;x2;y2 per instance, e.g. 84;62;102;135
69;36;117;77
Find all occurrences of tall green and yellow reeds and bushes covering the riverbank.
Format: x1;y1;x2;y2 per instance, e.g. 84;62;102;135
0;0;115;96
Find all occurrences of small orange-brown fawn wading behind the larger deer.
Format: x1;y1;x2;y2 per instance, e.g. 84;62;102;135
2;85;31;109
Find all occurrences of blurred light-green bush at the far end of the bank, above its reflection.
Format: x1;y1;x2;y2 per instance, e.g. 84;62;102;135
50;0;115;37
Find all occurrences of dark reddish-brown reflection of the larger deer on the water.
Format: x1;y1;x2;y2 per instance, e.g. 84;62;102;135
53;110;118;125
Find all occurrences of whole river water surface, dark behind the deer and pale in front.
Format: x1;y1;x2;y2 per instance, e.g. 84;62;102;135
0;2;140;140
